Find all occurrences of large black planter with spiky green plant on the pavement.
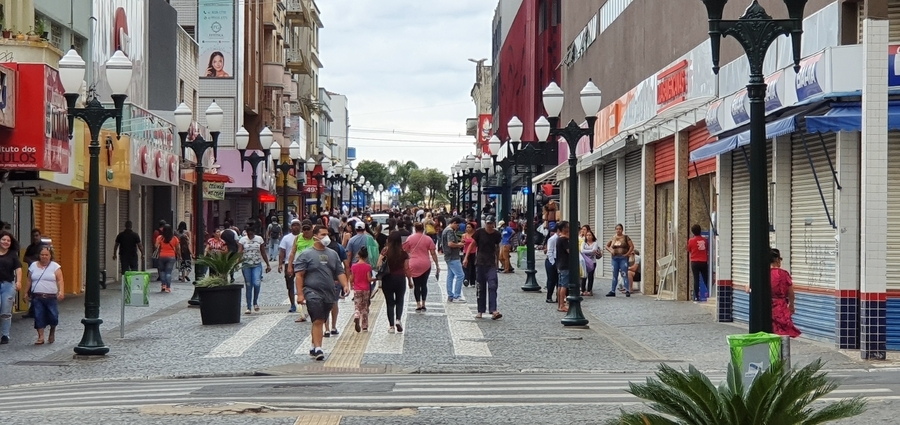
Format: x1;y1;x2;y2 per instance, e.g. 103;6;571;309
196;252;243;325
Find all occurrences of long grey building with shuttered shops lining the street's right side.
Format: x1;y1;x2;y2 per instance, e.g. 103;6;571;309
548;0;900;359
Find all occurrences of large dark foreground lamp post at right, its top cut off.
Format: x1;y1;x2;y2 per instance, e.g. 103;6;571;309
703;0;807;333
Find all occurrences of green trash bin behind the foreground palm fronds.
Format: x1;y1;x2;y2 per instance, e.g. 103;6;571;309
726;332;781;388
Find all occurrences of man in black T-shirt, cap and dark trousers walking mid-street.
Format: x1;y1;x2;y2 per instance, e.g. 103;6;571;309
463;215;503;320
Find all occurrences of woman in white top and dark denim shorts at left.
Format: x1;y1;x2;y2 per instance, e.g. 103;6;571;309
28;245;65;345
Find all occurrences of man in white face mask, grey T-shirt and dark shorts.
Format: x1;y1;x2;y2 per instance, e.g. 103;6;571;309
294;225;350;361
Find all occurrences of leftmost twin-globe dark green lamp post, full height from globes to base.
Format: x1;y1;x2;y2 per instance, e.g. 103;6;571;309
59;46;132;356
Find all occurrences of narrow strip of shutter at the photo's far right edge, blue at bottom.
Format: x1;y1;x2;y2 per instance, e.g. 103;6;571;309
885;131;900;350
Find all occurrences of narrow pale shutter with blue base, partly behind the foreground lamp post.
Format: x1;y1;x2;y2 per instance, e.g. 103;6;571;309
731;142;772;322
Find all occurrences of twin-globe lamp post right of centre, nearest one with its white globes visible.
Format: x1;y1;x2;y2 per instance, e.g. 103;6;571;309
543;80;601;326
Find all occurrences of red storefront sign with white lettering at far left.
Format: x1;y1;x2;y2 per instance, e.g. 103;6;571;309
0;64;71;173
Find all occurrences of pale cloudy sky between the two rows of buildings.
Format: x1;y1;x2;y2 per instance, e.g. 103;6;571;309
316;0;496;174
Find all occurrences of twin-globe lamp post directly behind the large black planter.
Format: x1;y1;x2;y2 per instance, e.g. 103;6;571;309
175;100;225;305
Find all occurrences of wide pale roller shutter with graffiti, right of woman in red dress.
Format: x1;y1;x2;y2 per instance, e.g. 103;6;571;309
791;133;836;288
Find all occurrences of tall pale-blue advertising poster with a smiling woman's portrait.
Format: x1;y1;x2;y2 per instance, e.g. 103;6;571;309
197;0;235;78
